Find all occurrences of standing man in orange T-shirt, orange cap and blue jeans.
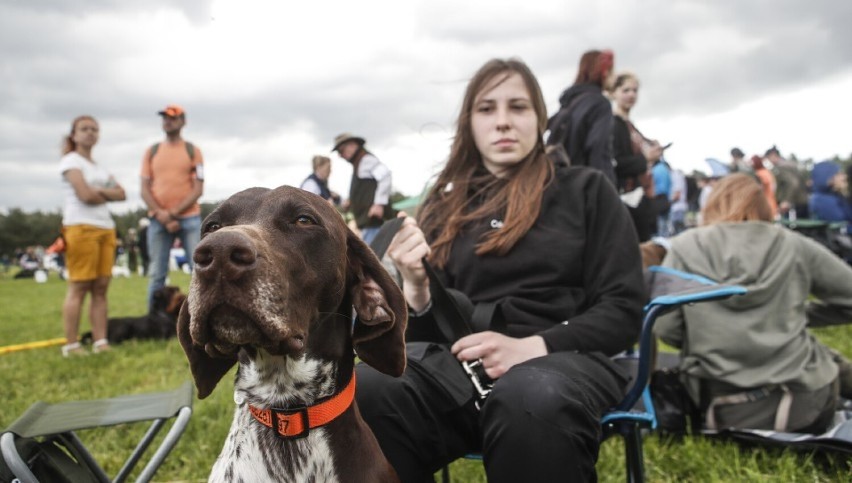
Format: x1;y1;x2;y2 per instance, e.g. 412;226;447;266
141;105;204;307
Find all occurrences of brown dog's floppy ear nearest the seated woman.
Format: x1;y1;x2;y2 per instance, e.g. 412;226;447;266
346;232;408;376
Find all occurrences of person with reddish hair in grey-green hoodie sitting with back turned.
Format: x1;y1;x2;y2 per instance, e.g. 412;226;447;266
655;174;852;433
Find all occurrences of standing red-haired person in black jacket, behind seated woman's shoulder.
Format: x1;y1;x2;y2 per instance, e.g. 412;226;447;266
547;50;616;184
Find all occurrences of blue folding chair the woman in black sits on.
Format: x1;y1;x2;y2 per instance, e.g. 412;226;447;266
442;266;746;483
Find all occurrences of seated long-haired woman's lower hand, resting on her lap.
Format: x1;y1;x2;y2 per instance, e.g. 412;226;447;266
450;330;547;379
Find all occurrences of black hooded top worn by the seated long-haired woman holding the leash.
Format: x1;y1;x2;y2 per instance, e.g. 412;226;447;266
407;167;644;355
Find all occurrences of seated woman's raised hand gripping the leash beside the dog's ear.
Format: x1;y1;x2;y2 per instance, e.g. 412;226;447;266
388;212;432;312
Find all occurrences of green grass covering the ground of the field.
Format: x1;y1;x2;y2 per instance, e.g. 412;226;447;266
0;272;852;482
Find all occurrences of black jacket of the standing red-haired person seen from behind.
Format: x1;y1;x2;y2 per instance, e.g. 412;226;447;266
547;84;615;184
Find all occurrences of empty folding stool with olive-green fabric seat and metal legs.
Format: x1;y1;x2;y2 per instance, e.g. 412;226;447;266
0;381;193;483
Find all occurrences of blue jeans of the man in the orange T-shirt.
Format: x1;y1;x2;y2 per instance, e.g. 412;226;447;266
148;215;201;308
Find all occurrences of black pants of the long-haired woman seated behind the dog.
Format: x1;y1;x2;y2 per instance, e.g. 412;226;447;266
356;352;626;483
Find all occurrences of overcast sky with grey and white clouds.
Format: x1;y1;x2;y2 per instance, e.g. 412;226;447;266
0;0;852;216
